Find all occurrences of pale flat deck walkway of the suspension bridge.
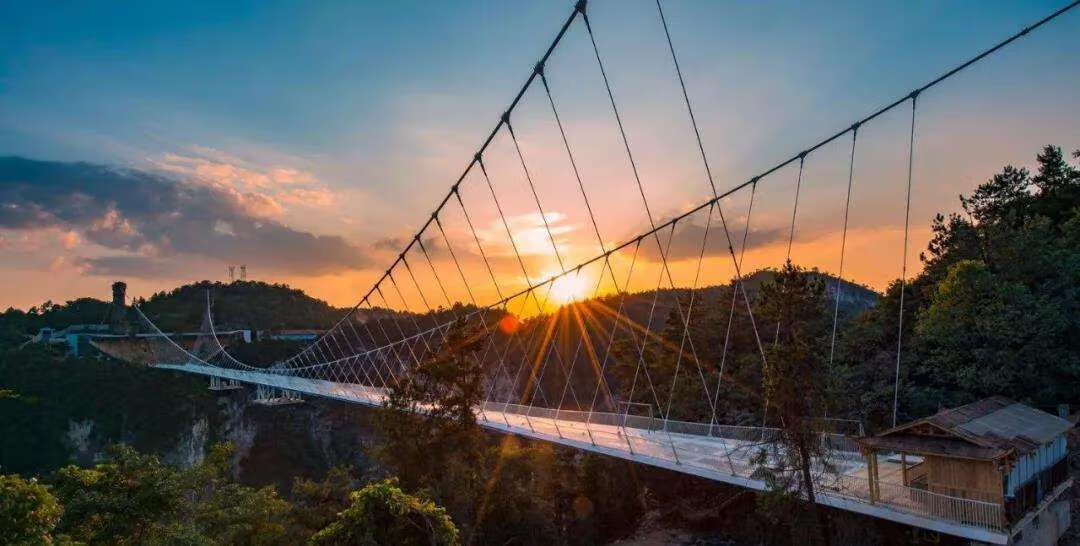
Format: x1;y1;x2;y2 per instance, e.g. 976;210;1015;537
154;363;1009;544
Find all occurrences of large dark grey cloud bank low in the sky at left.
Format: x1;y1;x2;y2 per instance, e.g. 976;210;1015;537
0;158;369;274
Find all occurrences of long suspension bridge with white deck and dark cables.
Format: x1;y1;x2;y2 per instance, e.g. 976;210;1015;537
120;0;1080;544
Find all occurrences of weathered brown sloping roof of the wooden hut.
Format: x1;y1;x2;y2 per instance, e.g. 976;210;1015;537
862;396;1072;460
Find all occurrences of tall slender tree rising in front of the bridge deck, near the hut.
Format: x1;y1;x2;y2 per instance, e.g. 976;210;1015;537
757;260;829;544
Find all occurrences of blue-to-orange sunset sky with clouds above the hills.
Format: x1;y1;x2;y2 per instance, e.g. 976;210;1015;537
0;0;1080;309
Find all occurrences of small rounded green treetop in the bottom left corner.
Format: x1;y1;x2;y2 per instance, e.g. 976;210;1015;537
0;474;64;546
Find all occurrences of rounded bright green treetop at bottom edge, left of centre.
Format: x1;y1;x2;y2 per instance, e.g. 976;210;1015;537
310;480;460;546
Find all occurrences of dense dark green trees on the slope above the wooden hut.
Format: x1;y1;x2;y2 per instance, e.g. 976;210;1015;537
902;146;1080;422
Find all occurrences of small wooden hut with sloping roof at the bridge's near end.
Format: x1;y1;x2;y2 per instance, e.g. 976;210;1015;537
855;396;1074;544
